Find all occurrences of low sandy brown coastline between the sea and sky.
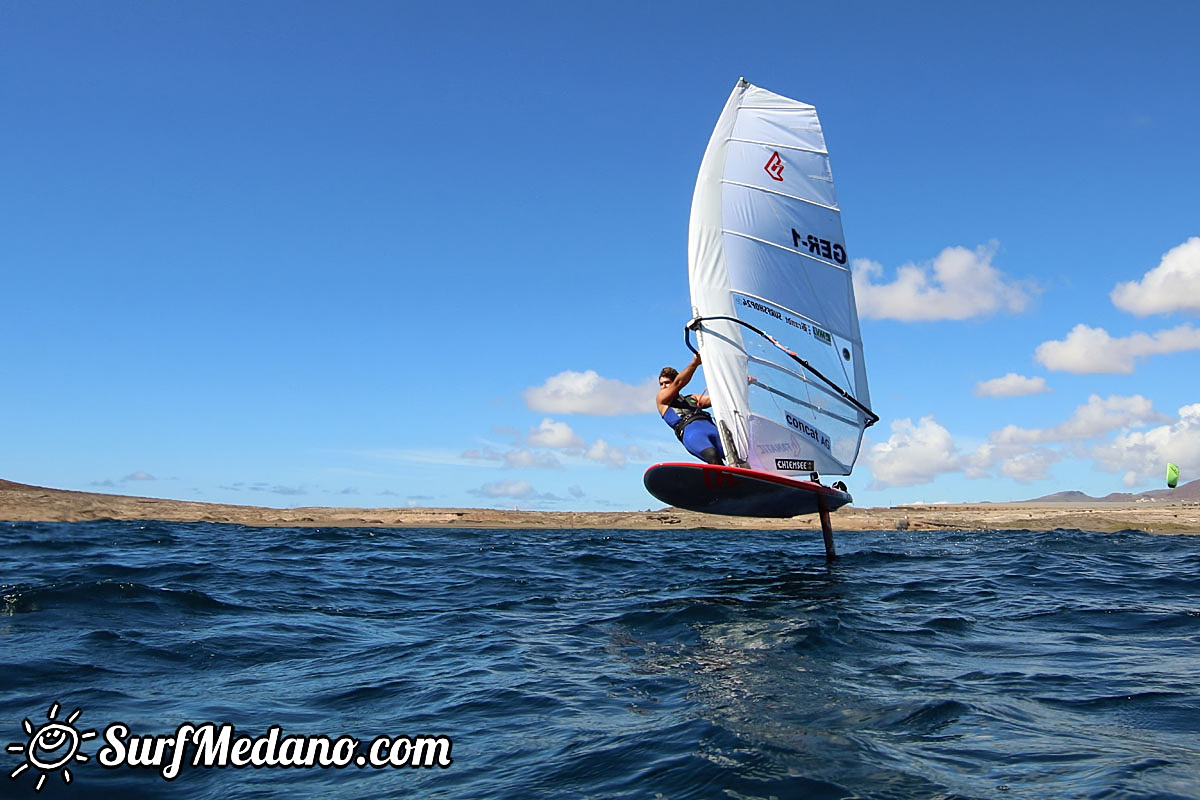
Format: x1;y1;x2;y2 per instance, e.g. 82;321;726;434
0;480;1200;534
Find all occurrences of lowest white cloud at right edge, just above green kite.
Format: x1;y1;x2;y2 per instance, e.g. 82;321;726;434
1091;403;1200;488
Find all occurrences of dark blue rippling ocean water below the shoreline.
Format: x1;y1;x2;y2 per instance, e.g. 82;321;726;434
0;516;1200;800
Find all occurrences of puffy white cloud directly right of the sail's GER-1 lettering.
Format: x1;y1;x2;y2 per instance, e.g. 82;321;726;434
854;243;1037;321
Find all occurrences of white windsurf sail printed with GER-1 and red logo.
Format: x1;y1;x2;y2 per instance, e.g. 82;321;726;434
688;80;877;477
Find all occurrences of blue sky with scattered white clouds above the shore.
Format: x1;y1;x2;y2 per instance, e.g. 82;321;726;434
0;0;1200;510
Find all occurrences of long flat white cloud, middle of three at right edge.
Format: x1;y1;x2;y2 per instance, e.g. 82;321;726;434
1033;323;1200;375
